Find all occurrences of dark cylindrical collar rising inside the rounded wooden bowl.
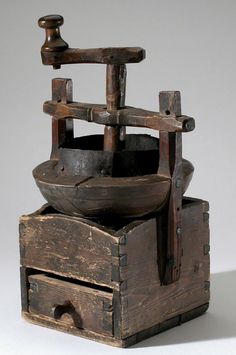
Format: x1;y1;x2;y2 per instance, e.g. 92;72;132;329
58;134;159;177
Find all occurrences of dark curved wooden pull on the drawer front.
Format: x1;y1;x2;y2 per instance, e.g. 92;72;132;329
52;301;83;329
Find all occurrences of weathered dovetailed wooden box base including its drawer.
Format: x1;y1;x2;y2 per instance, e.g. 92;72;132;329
20;198;210;347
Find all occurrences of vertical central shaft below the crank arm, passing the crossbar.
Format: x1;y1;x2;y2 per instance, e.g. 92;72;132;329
104;64;126;152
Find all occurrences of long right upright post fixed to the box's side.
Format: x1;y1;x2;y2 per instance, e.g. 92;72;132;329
158;91;183;284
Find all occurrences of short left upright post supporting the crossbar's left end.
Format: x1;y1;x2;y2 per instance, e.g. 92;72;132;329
50;78;74;159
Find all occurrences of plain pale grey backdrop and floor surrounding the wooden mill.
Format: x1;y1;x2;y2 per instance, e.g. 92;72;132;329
0;0;236;355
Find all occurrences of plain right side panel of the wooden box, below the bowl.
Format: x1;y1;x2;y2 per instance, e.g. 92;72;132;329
116;201;209;338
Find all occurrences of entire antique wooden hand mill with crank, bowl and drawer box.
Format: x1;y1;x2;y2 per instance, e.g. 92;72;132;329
20;15;210;347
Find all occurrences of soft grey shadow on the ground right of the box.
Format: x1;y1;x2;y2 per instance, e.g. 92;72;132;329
132;270;236;348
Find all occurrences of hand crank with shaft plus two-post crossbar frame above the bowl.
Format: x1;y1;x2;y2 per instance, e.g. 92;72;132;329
38;15;194;284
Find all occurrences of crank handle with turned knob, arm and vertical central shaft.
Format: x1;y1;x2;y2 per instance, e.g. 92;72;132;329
38;15;145;151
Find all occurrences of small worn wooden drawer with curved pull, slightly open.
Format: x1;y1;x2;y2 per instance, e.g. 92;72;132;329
28;274;113;336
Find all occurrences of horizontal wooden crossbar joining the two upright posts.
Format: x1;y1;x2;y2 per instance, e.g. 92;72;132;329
43;101;195;132
